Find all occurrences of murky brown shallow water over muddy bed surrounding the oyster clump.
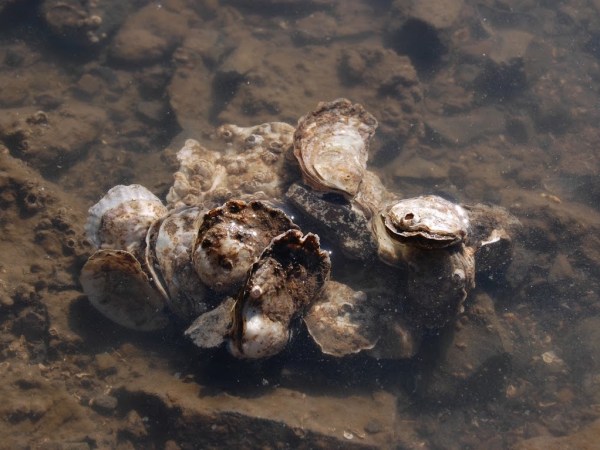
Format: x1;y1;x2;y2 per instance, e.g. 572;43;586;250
0;0;600;449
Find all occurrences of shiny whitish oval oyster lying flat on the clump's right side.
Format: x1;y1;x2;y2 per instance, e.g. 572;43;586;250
381;195;469;248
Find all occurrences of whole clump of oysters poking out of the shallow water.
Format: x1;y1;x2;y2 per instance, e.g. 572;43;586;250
81;99;516;358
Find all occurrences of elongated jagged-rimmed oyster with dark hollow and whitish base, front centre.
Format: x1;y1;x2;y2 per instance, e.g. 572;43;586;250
229;230;331;358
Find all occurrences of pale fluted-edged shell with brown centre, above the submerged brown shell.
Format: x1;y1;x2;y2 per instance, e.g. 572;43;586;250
85;184;167;252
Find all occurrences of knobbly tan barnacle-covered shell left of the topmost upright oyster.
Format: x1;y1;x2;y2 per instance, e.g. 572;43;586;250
167;122;294;208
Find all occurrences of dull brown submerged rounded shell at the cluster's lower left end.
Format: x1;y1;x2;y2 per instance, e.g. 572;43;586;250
80;250;168;331
